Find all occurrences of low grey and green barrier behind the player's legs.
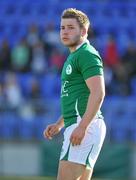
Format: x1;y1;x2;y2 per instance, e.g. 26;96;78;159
0;136;132;180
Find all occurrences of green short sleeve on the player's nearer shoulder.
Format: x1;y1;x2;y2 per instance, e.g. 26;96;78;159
78;51;103;80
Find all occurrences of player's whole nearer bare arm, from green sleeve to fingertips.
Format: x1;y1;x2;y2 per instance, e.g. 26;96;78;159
70;75;105;145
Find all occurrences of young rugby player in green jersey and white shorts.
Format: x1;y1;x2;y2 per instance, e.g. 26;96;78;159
44;8;106;180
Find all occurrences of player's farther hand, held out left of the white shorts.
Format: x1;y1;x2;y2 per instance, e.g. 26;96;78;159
43;124;61;139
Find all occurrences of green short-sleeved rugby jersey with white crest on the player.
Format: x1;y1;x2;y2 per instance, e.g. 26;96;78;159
61;42;103;127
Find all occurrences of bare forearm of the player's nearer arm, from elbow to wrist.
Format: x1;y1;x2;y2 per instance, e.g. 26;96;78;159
79;92;104;129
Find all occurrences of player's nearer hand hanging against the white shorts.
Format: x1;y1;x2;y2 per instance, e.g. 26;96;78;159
70;126;85;146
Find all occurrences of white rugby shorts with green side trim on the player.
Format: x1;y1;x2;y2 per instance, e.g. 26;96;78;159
60;116;106;168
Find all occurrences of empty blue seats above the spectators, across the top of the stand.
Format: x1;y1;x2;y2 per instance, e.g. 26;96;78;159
0;0;136;53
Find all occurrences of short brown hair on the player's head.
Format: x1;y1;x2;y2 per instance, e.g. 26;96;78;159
61;8;90;28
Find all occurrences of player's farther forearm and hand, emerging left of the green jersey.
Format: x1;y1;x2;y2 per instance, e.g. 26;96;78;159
43;116;64;139
